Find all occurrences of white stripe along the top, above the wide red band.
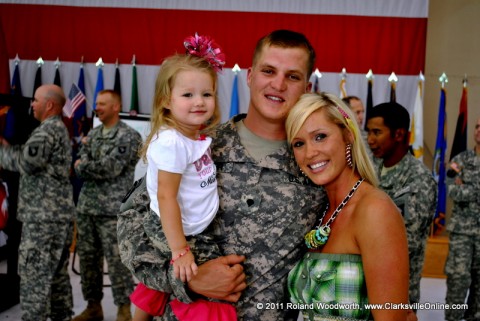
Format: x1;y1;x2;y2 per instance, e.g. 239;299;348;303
0;0;429;18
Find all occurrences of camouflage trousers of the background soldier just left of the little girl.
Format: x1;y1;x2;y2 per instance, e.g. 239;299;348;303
76;215;133;306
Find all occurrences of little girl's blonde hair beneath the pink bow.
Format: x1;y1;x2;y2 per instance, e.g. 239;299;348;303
140;54;220;160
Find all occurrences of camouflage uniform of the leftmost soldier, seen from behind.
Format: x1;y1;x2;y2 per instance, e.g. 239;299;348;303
0;116;74;321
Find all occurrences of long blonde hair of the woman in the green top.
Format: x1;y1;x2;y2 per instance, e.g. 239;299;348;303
285;93;378;186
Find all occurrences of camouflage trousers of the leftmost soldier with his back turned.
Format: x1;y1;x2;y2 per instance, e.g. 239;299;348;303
18;221;73;321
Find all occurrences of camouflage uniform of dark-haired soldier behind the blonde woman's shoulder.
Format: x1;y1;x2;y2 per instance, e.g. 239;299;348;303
376;153;437;303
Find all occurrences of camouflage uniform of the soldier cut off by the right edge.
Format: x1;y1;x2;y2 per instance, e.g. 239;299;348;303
445;150;480;320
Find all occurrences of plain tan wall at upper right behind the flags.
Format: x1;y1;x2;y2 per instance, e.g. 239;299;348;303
424;0;480;168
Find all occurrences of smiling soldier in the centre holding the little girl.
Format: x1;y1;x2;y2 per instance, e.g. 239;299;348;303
119;30;325;321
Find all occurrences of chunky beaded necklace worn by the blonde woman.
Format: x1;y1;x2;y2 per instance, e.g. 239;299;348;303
305;178;364;249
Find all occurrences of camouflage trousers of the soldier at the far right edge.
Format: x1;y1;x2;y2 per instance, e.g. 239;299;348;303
445;232;480;321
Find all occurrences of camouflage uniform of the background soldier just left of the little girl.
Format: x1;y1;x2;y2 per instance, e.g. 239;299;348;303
75;121;141;306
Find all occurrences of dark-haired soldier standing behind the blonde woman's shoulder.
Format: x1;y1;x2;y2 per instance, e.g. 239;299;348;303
367;102;437;310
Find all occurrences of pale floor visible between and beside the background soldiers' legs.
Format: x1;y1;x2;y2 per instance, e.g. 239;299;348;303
0;255;446;321
